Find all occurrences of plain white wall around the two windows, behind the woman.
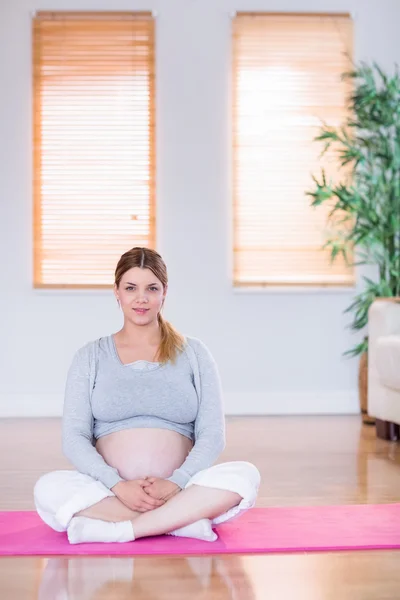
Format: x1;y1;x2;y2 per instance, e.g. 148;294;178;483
0;0;400;416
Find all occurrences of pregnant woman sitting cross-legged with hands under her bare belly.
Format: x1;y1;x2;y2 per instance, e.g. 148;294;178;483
34;248;260;544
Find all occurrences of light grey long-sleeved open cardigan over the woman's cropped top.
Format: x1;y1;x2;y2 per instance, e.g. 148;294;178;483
62;336;225;489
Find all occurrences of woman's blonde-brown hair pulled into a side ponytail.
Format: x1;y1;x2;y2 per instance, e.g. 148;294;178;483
115;247;186;363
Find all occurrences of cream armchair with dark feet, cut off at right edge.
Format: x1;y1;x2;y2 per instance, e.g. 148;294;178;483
368;298;400;440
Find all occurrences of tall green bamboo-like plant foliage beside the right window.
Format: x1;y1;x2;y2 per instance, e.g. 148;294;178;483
307;63;400;356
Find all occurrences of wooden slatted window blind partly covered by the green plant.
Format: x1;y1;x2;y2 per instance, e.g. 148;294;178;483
233;13;354;287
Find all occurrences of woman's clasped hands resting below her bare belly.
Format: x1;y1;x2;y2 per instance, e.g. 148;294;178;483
112;477;181;512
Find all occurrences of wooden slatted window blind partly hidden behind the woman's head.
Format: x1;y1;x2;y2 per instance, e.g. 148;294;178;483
33;12;155;288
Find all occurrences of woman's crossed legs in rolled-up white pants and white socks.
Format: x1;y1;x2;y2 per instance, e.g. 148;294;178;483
35;461;260;543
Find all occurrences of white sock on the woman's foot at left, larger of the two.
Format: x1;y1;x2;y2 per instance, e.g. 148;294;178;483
67;517;135;544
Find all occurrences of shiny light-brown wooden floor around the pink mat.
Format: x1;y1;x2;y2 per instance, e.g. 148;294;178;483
0;416;400;600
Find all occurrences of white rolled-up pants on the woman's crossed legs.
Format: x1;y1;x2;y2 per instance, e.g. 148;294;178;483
34;461;260;531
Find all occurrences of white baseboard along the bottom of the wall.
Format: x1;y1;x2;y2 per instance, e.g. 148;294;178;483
0;390;360;418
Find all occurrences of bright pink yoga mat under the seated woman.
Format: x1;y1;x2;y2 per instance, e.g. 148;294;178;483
0;504;400;556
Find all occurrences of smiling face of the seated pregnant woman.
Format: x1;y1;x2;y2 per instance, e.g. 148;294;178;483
114;267;167;325
